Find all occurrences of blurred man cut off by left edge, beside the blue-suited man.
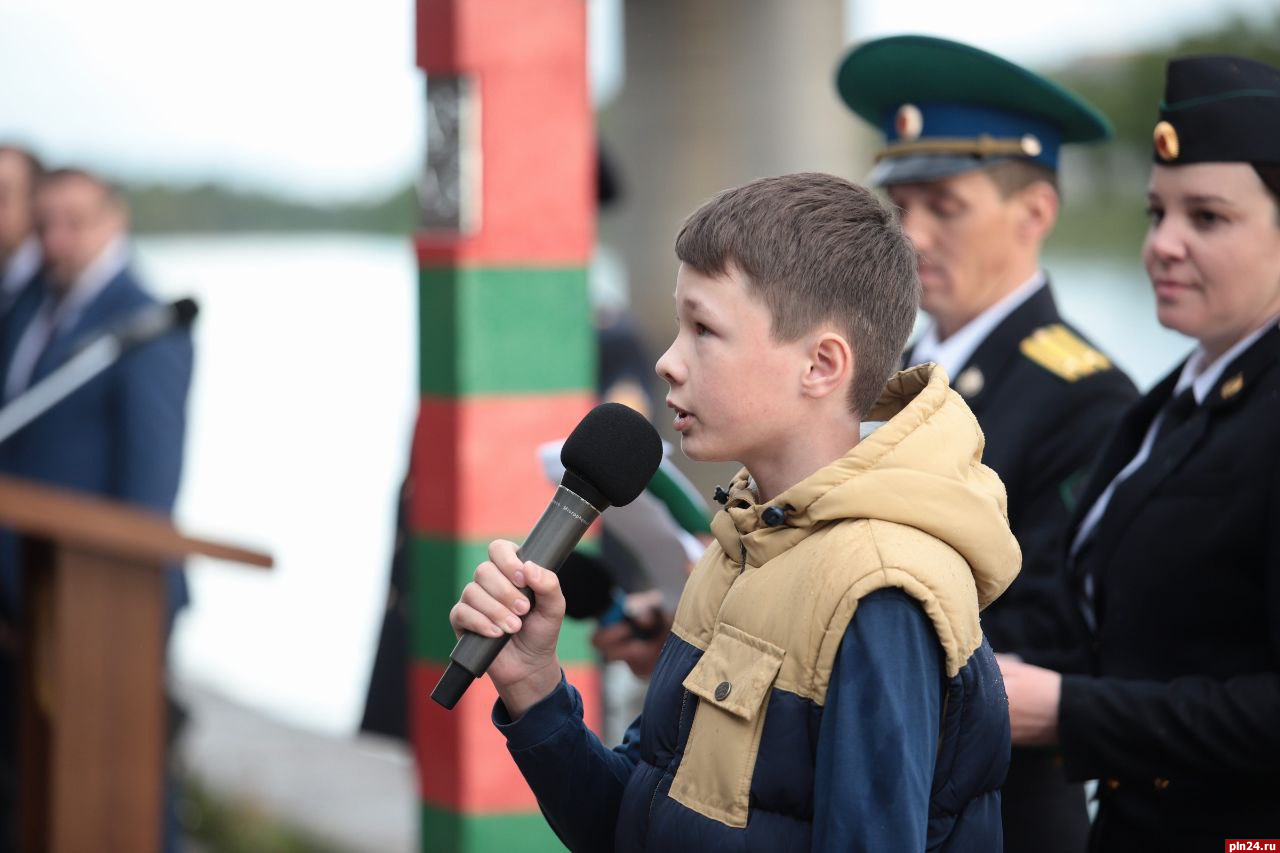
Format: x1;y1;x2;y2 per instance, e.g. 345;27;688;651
0;145;45;330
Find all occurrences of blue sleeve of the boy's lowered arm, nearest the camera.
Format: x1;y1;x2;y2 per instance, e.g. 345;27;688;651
813;589;942;850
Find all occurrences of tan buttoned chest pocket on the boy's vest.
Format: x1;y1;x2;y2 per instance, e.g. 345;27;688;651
669;622;783;827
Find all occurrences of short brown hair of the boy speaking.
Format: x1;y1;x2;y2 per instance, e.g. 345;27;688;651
676;172;920;415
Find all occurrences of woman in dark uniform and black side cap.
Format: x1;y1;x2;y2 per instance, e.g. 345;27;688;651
1001;56;1280;853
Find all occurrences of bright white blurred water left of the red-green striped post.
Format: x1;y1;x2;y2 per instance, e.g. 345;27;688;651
137;233;417;734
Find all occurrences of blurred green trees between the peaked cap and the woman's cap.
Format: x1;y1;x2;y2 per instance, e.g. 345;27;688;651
1047;12;1280;256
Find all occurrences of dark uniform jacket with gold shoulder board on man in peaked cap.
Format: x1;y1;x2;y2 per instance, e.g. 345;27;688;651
906;284;1138;853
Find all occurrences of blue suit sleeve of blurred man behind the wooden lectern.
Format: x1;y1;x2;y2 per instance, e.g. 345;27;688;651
113;326;192;514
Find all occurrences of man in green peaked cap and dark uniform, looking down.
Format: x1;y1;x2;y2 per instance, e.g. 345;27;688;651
836;36;1137;853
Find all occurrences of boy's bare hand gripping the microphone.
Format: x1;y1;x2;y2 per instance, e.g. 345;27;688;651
449;539;564;720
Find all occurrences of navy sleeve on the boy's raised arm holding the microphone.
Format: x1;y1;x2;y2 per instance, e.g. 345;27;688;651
493;672;640;852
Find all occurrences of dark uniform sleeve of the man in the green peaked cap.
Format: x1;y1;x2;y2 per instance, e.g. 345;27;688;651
983;370;1138;669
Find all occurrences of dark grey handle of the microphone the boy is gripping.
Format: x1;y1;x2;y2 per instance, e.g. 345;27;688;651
431;484;600;710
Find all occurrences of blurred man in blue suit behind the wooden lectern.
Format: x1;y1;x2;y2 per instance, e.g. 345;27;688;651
0;169;192;849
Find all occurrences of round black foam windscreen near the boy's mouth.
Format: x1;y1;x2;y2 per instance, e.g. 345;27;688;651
561;403;662;506
